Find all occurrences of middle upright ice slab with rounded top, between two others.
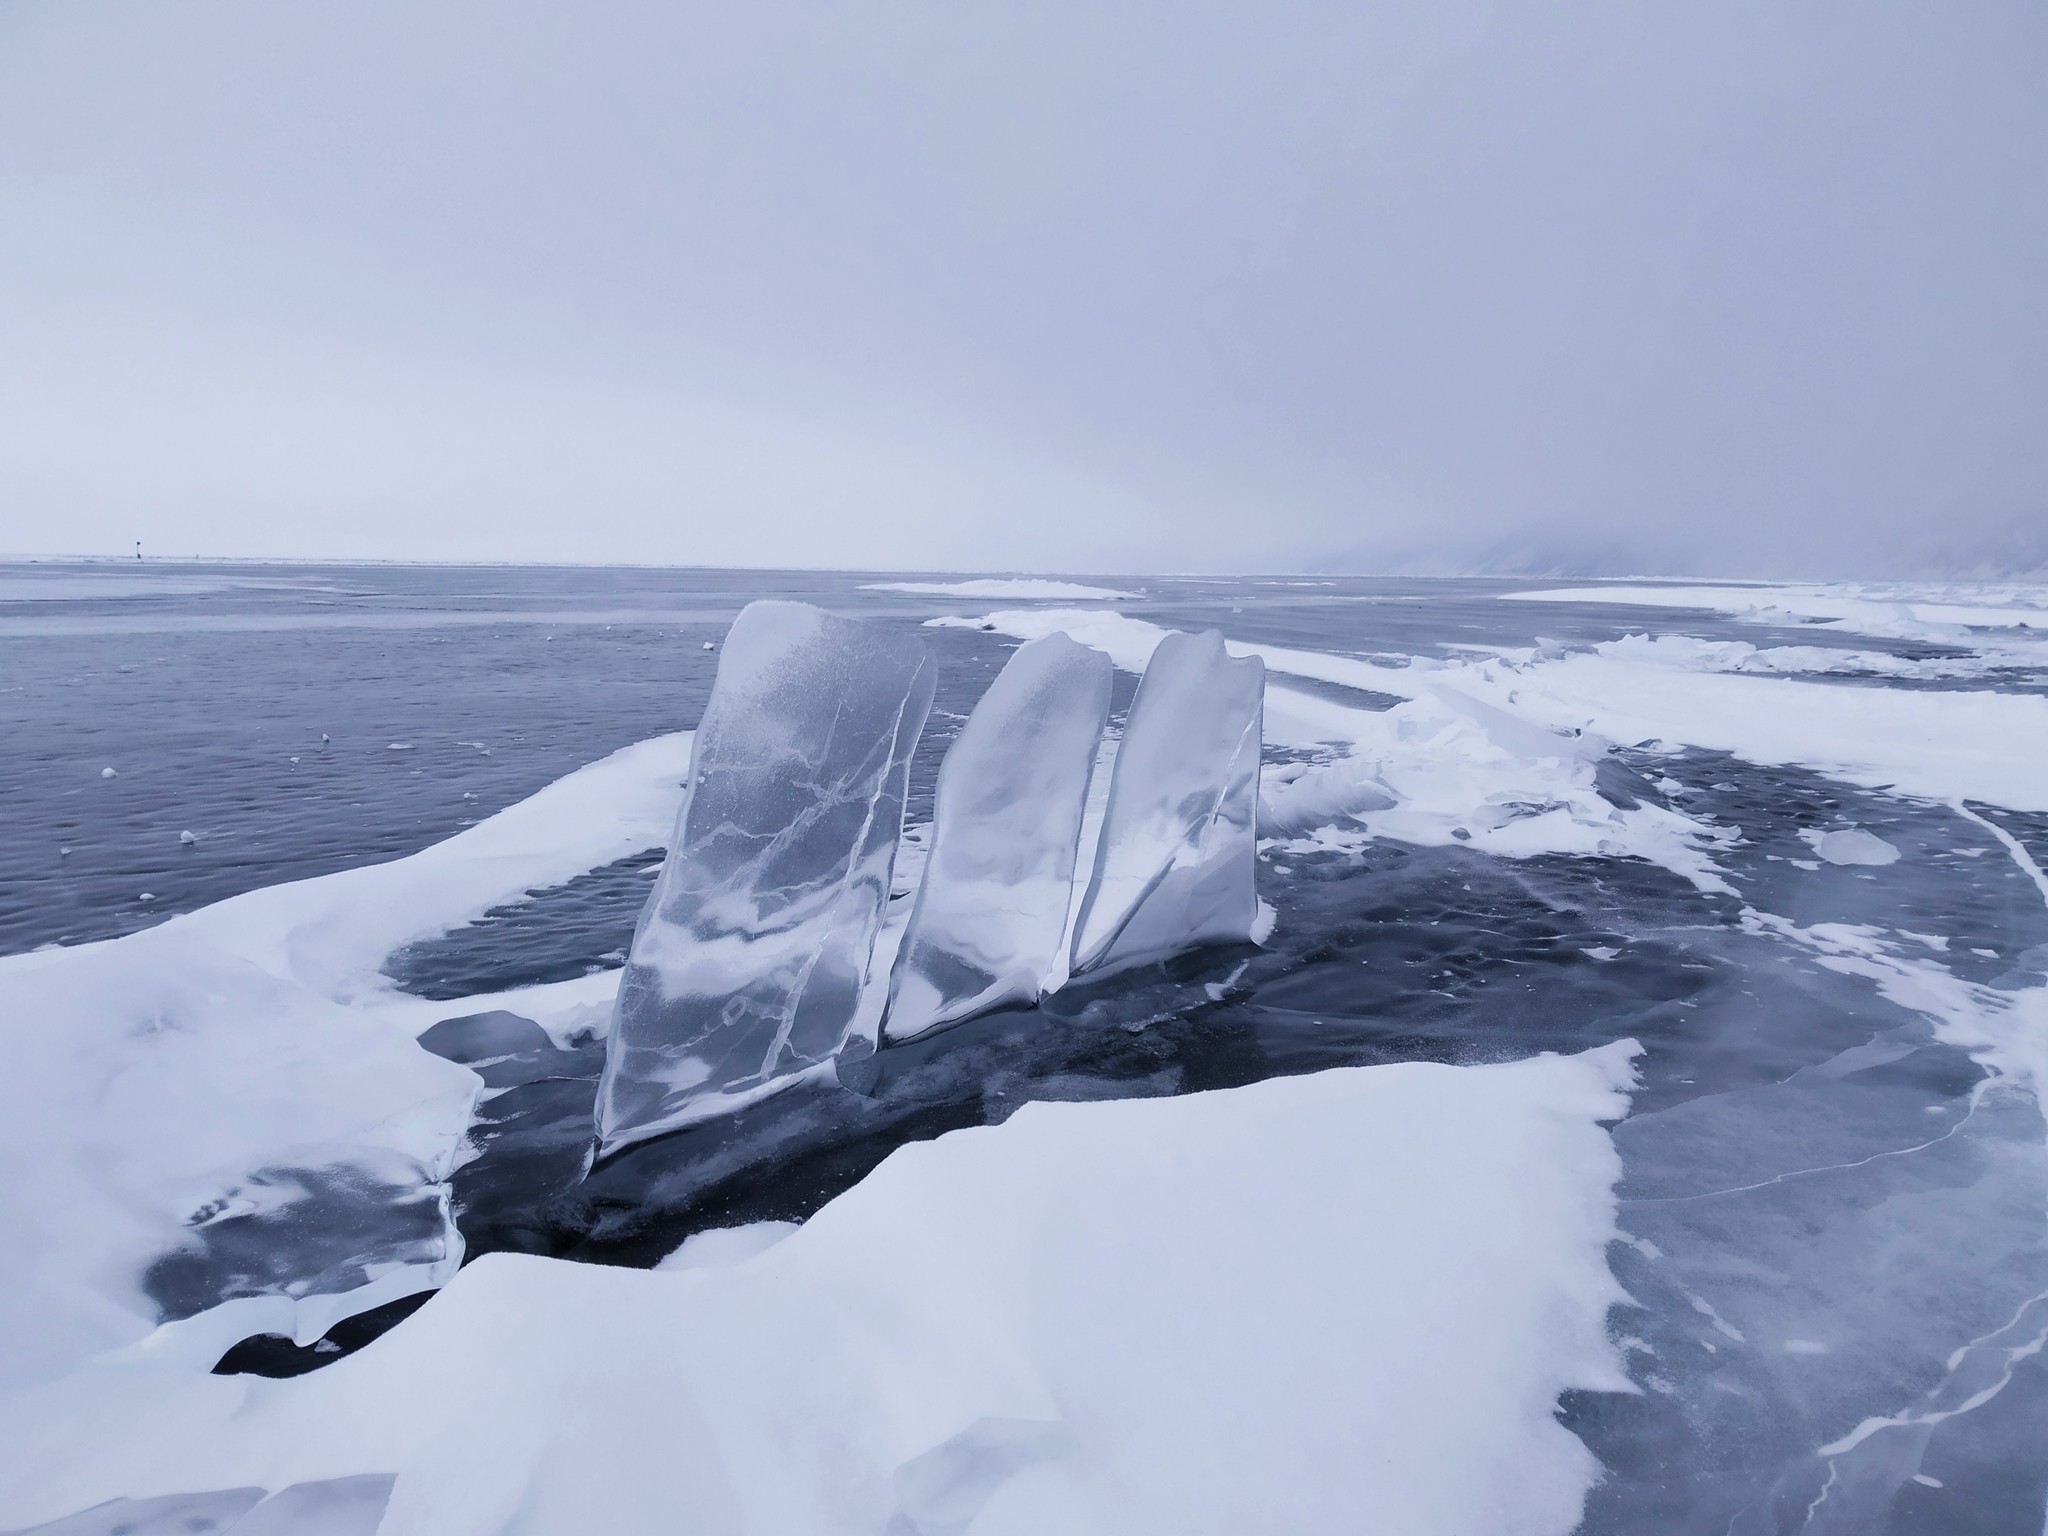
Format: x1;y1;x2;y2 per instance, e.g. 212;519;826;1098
883;635;1110;1040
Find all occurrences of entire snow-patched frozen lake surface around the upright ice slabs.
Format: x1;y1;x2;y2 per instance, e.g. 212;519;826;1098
0;563;2048;1536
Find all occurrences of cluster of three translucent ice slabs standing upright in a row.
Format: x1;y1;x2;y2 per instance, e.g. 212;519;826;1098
596;602;1266;1155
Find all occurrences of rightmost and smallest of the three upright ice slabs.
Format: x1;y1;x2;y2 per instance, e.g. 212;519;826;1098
1073;629;1266;975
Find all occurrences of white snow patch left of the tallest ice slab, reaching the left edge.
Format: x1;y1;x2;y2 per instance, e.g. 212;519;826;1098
0;733;690;1384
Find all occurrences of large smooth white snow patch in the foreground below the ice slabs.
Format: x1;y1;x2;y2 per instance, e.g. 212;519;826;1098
0;1042;1636;1536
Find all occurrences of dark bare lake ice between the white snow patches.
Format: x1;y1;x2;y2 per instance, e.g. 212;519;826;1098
12;569;2048;1536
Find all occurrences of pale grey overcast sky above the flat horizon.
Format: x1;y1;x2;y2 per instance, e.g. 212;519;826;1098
0;0;2048;575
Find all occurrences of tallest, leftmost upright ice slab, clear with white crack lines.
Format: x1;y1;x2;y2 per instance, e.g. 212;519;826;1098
598;602;934;1153
